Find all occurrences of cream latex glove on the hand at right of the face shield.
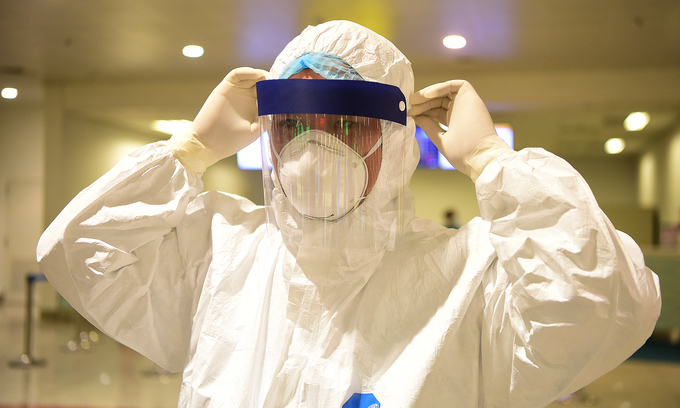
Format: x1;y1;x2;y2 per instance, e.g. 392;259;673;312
409;80;513;181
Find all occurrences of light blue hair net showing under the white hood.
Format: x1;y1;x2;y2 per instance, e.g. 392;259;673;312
280;52;364;81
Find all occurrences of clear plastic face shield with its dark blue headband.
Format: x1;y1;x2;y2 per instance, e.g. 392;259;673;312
257;79;406;253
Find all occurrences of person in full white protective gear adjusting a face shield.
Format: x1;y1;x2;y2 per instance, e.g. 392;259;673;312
37;22;660;408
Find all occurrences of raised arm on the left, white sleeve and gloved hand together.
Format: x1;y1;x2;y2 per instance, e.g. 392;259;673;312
37;68;268;371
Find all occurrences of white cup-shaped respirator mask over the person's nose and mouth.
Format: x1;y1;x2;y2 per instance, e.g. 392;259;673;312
275;130;382;221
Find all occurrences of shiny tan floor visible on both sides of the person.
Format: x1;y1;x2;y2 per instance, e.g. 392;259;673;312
0;305;680;408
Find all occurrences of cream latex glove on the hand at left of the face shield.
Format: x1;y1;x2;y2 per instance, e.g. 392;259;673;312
168;68;269;173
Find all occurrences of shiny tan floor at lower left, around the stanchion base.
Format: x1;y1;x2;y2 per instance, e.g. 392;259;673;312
0;306;181;408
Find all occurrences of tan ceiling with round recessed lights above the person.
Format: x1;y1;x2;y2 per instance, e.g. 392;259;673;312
0;0;680;157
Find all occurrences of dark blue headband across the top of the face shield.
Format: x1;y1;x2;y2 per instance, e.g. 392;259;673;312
256;79;406;125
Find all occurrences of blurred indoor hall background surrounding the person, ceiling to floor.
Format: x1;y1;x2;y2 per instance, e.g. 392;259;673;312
0;0;680;408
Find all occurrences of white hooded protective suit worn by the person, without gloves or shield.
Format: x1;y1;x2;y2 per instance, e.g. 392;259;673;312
37;23;660;408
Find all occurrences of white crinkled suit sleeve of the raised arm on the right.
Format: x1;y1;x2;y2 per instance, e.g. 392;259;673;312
476;149;661;407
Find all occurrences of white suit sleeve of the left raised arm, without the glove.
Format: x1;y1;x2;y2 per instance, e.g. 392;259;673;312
37;142;210;371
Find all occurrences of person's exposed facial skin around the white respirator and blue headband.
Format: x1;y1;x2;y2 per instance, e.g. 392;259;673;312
271;69;382;198
